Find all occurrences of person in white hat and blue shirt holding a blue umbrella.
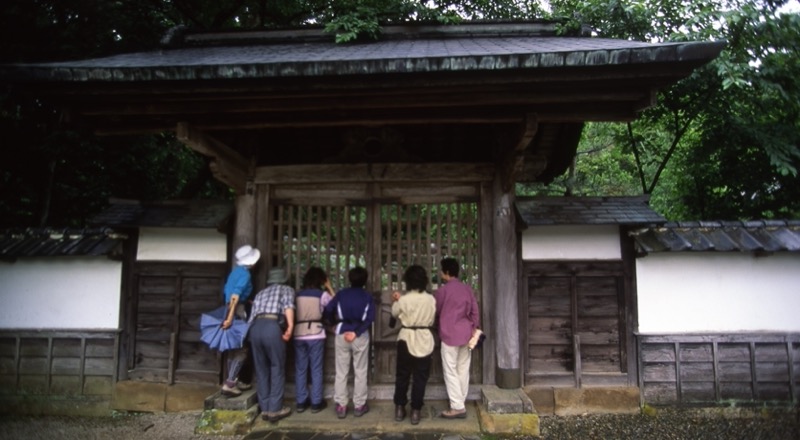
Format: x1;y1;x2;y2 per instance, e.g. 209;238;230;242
221;244;261;397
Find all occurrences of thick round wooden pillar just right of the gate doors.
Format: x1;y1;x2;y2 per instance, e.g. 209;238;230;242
493;175;522;389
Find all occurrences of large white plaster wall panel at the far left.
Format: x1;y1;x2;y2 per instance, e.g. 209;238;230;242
0;257;122;330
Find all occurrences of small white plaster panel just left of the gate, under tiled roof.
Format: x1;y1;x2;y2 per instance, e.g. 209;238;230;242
136;228;228;262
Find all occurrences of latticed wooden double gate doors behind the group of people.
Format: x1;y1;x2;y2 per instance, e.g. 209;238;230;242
268;187;481;383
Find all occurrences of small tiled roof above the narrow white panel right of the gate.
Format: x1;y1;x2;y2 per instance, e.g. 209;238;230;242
516;197;666;226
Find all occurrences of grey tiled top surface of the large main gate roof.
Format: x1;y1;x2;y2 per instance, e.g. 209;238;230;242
0;24;724;82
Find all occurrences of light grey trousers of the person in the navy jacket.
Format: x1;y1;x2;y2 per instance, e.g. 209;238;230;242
333;332;369;407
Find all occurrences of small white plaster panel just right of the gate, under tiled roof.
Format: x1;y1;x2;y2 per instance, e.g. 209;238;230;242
522;225;622;260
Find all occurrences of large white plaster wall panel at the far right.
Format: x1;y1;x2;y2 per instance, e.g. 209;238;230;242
636;252;800;334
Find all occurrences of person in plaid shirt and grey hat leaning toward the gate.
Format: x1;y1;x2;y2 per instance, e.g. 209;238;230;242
248;268;295;423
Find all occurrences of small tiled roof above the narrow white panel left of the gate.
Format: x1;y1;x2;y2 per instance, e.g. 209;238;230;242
89;200;234;229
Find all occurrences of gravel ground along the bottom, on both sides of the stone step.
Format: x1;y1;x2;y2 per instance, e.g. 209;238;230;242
0;408;800;440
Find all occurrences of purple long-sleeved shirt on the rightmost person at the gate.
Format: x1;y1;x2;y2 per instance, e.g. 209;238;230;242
436;278;481;347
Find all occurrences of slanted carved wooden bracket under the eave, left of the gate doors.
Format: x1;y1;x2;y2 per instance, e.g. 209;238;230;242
176;122;250;194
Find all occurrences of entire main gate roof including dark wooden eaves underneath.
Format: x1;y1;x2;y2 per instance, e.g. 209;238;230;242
0;26;723;183
